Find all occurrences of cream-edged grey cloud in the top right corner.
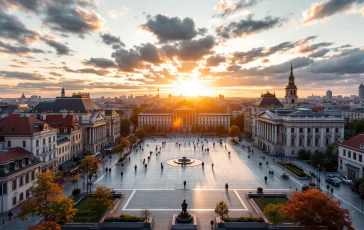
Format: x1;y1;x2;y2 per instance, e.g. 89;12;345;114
303;0;364;23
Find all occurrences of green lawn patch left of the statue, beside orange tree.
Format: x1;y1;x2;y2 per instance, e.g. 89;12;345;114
73;197;116;222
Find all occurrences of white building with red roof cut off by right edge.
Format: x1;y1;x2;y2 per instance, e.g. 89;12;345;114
338;134;364;179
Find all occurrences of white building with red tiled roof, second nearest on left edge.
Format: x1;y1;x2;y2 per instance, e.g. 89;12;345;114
0;115;58;171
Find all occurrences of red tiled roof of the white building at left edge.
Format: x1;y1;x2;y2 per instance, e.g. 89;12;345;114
0;115;50;135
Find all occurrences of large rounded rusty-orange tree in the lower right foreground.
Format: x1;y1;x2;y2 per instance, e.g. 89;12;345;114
282;189;354;230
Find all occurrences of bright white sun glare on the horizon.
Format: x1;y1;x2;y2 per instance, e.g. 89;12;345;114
176;79;213;97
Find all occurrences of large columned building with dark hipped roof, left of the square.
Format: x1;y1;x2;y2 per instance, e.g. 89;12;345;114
31;89;120;154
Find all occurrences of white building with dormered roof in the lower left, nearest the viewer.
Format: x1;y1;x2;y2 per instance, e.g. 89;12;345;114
0;147;41;213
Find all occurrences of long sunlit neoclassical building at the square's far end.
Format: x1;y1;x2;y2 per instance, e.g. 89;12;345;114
138;106;230;133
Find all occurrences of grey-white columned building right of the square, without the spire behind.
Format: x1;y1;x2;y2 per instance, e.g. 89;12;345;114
254;109;345;157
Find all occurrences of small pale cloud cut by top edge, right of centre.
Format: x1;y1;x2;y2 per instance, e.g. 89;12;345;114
214;0;261;17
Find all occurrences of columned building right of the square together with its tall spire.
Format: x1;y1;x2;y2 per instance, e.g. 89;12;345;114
244;66;345;156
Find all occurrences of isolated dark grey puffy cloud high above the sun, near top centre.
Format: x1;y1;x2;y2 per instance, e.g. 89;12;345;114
141;14;198;42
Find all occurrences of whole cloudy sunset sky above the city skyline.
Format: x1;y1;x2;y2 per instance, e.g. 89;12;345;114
0;0;364;98
